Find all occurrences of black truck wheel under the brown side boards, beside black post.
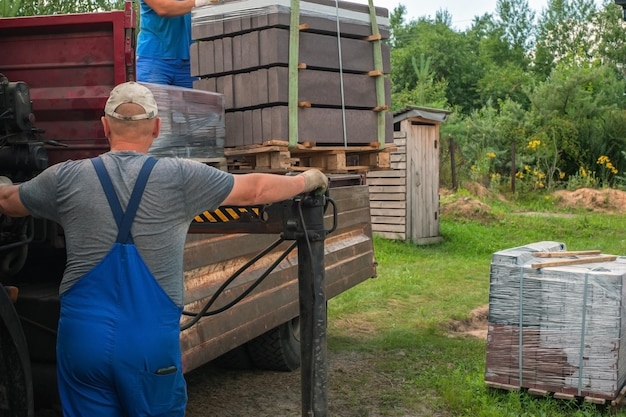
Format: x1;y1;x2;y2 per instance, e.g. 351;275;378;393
247;317;300;372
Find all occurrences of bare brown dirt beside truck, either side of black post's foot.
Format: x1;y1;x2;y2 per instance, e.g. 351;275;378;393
187;353;410;417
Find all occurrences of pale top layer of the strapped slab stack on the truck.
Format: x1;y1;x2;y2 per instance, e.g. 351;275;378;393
191;0;390;40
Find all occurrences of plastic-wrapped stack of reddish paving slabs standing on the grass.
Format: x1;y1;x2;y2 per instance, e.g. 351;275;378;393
485;241;626;400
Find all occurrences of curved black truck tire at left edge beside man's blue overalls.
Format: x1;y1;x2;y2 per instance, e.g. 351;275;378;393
0;284;34;417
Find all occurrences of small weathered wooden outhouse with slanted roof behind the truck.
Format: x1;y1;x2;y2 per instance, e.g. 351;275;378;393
367;106;450;245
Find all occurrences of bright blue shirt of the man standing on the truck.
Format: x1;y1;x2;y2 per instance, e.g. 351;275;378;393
137;0;192;59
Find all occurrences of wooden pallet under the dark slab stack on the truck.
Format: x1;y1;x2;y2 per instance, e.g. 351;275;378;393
224;140;395;174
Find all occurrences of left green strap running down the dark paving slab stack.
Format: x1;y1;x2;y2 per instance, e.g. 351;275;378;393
288;0;300;149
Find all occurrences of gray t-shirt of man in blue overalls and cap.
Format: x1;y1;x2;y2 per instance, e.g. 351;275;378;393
19;151;234;305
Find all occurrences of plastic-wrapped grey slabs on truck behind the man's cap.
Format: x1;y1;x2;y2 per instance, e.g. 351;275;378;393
141;83;225;159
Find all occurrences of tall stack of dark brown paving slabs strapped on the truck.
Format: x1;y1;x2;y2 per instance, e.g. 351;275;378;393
191;0;393;147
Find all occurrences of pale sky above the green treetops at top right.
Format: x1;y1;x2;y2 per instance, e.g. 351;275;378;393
346;0;602;30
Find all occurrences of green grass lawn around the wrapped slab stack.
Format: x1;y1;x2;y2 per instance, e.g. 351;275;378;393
328;189;626;417
